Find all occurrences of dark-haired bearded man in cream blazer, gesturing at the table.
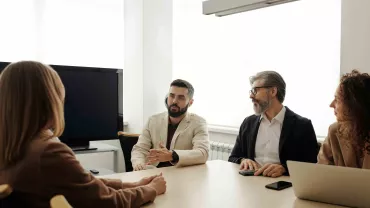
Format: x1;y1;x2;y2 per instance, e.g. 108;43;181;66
131;79;209;171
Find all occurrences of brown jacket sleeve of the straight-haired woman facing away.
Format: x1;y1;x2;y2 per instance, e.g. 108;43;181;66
40;142;156;208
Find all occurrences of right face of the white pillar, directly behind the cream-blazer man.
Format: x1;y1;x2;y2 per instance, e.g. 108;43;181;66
143;0;172;120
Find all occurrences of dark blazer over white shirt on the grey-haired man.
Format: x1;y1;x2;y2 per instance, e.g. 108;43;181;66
229;107;319;175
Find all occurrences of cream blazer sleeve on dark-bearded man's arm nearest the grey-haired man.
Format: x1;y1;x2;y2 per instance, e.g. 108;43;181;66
175;120;210;166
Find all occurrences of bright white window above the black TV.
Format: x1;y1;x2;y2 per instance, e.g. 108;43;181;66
0;0;124;68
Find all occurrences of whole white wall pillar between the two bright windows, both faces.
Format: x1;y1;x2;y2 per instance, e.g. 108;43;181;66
123;0;172;133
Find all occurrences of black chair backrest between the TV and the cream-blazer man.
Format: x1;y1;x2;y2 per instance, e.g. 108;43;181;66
118;132;140;172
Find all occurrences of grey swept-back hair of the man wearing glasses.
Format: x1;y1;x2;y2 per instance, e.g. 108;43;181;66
249;71;286;103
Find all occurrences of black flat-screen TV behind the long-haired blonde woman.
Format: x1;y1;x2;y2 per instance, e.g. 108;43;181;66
0;62;123;150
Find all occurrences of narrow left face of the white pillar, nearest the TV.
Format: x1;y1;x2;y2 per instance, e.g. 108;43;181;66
123;0;144;132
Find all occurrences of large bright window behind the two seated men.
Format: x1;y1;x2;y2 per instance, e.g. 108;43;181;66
173;0;341;136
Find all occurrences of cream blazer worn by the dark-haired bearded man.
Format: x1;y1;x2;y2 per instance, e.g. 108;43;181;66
131;112;209;167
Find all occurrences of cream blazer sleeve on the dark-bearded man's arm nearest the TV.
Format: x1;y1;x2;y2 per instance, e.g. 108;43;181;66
131;118;153;168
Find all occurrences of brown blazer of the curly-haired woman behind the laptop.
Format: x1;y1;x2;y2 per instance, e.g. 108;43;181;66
317;123;370;169
